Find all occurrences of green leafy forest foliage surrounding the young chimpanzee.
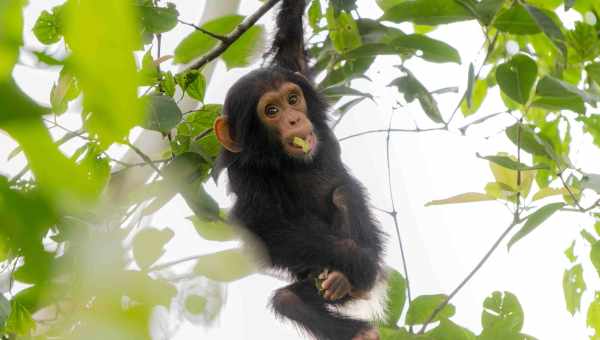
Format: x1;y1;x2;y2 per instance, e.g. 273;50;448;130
0;0;600;340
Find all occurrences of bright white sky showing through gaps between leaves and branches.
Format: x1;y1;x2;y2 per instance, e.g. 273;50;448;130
0;0;600;340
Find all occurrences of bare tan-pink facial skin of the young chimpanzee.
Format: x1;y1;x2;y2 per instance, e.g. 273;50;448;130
256;82;318;158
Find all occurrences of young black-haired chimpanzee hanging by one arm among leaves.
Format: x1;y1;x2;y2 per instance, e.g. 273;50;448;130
213;0;383;340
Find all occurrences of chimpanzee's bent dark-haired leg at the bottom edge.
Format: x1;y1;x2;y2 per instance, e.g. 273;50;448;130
272;279;379;340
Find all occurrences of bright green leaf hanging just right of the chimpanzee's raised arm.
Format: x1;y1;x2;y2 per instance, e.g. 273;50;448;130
327;6;362;53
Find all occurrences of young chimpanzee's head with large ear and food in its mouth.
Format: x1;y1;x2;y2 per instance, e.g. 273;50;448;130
214;66;329;173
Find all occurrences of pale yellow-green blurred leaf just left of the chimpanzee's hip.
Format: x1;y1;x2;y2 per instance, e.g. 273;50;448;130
194;249;257;282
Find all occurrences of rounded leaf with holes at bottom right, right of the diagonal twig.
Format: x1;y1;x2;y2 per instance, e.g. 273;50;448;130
481;291;523;332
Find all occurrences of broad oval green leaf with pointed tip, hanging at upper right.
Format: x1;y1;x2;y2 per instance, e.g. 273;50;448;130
496;54;538;104
